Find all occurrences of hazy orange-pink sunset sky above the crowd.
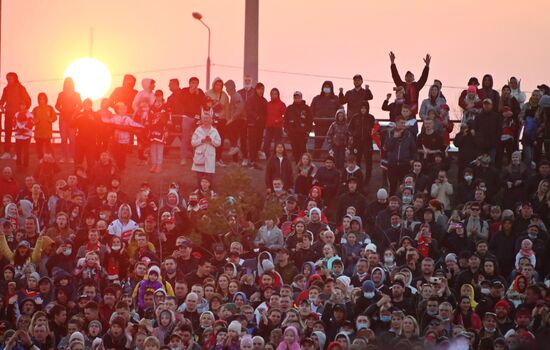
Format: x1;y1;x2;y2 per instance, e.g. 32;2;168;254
1;0;550;117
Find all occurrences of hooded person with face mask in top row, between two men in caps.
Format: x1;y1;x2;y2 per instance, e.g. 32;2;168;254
311;80;345;158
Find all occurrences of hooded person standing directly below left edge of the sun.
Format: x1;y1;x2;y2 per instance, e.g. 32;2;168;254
55;77;82;162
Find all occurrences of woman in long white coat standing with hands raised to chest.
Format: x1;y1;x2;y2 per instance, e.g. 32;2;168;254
191;112;221;186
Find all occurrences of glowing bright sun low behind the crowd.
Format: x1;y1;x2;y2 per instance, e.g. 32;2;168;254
64;57;111;100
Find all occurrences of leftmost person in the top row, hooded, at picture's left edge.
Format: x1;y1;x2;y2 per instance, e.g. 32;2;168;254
0;72;31;160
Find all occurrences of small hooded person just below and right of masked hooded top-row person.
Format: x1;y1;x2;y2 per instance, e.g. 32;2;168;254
326;109;351;171
